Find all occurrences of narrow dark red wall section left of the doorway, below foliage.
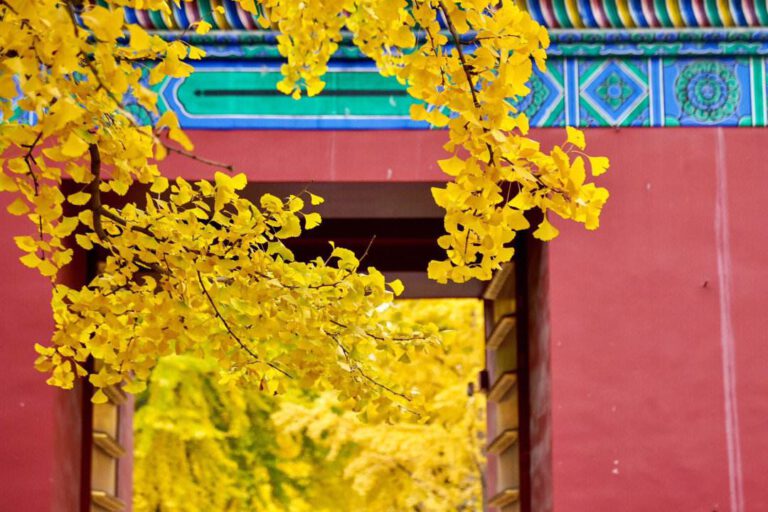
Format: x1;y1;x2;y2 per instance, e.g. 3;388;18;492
0;194;84;512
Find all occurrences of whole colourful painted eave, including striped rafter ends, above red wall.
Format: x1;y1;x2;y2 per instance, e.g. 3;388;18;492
127;0;768;130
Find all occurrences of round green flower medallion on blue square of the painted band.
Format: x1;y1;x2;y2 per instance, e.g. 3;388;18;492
675;62;741;123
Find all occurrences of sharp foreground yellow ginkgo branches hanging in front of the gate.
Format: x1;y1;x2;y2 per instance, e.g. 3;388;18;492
0;0;608;417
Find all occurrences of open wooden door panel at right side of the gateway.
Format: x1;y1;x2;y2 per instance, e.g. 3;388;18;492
483;263;520;512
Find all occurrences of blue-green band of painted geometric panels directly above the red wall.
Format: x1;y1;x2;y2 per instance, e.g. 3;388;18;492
153;56;768;129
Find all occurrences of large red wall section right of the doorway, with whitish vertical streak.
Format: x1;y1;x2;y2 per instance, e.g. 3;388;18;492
549;129;768;512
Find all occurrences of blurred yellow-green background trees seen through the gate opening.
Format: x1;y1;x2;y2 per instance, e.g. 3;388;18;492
134;300;484;512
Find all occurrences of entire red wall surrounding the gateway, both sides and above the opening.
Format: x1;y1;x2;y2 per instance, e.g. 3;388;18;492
0;128;768;512
